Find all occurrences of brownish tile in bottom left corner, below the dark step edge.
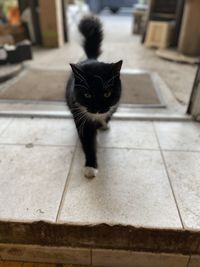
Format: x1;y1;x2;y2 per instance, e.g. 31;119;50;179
0;244;91;267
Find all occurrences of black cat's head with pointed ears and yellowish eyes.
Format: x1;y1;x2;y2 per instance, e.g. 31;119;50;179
70;60;122;113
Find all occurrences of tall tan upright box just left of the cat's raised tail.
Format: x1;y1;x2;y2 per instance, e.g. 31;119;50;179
39;0;64;47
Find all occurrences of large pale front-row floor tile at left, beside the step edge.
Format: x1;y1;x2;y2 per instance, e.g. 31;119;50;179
0;146;74;221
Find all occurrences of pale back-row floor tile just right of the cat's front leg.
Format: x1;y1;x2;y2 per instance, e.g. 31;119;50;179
98;121;158;149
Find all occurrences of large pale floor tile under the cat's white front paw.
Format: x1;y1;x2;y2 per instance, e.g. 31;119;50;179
59;149;181;228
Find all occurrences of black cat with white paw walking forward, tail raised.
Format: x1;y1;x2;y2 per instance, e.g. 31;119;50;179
66;16;122;178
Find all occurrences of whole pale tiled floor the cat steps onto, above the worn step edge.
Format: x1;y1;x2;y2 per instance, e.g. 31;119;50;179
0;118;200;230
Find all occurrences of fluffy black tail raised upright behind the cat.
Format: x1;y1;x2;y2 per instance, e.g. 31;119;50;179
78;16;103;59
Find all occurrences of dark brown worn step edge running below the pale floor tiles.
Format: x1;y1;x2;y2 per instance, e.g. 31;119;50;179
0;221;200;255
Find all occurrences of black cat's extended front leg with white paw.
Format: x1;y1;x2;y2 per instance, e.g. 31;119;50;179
77;122;98;178
